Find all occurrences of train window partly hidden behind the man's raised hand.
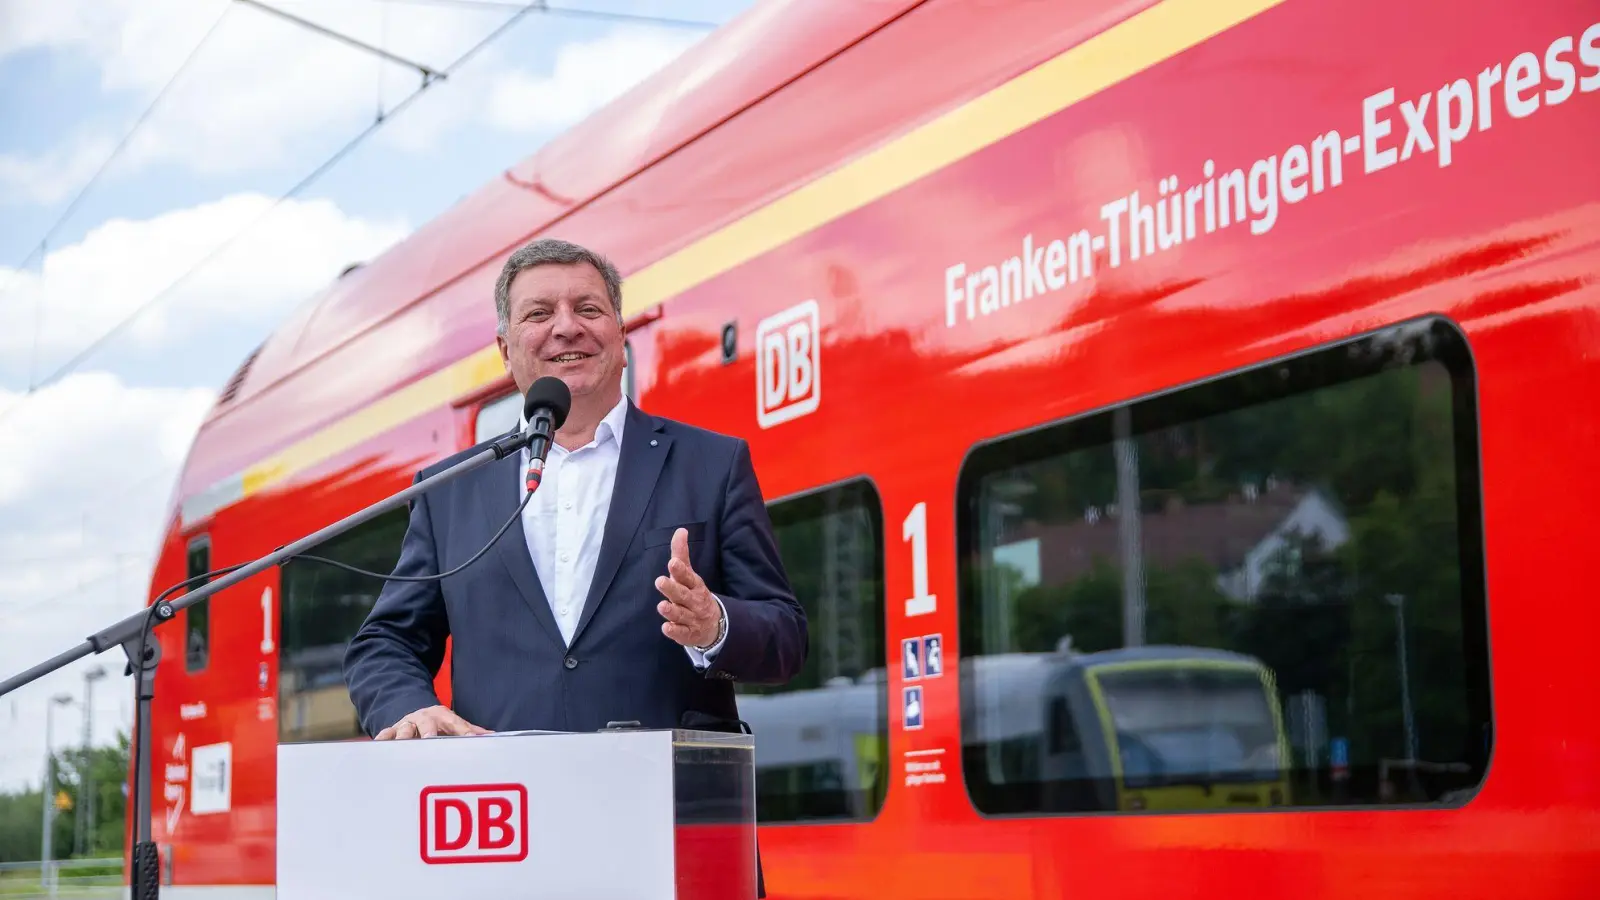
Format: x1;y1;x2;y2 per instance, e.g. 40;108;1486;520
738;480;890;823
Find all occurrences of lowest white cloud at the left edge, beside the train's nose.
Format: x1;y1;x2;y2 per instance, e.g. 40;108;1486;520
0;372;214;791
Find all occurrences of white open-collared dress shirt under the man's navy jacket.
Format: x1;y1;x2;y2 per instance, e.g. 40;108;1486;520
517;397;728;668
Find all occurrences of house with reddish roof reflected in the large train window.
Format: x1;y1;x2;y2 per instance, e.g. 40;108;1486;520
994;479;1350;602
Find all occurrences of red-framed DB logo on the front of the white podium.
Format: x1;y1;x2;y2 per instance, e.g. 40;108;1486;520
422;785;528;865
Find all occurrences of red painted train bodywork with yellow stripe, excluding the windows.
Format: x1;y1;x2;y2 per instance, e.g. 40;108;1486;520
128;0;1600;900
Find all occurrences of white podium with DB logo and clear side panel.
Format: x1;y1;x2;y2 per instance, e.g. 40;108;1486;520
277;729;757;900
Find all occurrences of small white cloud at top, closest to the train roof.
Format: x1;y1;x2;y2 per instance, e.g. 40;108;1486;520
485;29;701;131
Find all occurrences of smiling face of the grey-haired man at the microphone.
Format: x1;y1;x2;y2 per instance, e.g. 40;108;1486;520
496;263;626;400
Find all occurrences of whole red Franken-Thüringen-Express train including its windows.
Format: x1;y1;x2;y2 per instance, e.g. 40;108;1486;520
131;0;1600;900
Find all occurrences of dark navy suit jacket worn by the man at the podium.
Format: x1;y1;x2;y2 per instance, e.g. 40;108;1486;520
344;402;808;735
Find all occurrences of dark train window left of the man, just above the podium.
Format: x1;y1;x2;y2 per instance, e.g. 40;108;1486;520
278;506;410;743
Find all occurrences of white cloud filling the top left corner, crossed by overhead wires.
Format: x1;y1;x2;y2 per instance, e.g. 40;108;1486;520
0;0;506;203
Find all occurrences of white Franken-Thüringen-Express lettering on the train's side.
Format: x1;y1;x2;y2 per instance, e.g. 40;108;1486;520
944;22;1600;328
